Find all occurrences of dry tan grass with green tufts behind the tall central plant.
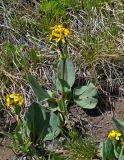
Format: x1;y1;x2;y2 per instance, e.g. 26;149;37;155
0;0;124;116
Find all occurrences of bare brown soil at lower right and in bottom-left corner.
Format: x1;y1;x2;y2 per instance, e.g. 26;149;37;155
0;101;124;160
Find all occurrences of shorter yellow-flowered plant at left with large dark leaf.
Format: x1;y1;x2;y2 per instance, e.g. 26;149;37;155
0;93;60;158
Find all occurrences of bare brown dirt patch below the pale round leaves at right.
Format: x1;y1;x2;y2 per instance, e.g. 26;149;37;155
71;100;124;142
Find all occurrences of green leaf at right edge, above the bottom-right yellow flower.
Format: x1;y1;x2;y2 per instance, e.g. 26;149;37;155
112;117;124;133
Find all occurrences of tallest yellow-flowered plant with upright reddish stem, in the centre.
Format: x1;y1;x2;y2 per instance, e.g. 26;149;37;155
28;24;98;131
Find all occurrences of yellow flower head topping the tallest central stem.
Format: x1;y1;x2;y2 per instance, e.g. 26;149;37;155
50;24;70;43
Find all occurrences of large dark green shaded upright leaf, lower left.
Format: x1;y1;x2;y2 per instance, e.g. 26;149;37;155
25;102;50;142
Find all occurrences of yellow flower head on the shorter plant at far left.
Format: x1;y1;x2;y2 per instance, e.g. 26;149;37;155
6;93;23;107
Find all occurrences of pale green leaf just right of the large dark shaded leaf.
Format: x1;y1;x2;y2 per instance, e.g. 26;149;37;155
45;112;61;140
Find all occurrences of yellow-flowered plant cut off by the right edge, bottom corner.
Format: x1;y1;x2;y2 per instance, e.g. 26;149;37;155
100;118;124;160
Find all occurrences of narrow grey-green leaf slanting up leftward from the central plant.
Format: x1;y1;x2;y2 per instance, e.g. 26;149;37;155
28;75;50;101
